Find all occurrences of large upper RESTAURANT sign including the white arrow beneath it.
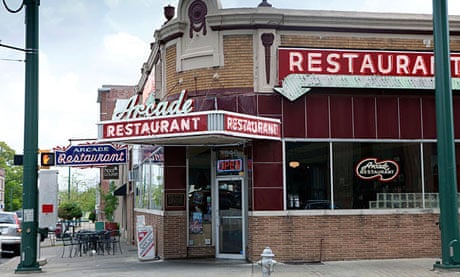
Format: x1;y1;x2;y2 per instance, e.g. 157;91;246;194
275;48;460;101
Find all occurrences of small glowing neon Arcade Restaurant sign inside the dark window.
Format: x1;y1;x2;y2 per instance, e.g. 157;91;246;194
355;158;399;182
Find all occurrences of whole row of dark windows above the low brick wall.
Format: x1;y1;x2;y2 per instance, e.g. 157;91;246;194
285;142;426;210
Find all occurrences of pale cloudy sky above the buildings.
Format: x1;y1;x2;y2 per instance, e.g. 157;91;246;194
0;0;460;183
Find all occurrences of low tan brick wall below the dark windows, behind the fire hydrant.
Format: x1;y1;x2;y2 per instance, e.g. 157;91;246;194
248;213;441;262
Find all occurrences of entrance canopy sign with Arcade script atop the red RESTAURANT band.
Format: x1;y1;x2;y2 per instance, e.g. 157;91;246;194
98;90;281;144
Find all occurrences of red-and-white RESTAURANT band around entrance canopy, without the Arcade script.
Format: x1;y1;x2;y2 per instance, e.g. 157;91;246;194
99;111;281;142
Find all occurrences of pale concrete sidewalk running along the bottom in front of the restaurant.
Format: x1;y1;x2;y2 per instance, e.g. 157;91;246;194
0;236;460;277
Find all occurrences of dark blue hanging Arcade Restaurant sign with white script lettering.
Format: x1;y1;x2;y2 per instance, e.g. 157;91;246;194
55;144;128;167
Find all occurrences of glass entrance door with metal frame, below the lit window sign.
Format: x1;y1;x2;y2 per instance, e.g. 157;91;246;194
216;177;245;258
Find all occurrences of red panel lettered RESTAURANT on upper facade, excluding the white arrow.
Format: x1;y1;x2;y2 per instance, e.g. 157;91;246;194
278;48;460;81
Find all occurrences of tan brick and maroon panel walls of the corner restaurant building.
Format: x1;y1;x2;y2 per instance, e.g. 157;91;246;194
102;0;460;262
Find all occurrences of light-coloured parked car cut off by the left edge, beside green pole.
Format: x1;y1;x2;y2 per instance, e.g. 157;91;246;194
0;212;21;257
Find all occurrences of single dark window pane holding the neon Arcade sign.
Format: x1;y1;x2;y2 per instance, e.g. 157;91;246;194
332;142;422;209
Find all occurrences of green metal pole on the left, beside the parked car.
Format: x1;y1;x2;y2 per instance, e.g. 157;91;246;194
16;0;41;272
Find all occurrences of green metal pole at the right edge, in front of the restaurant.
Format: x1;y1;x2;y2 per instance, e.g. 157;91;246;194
433;0;460;270
